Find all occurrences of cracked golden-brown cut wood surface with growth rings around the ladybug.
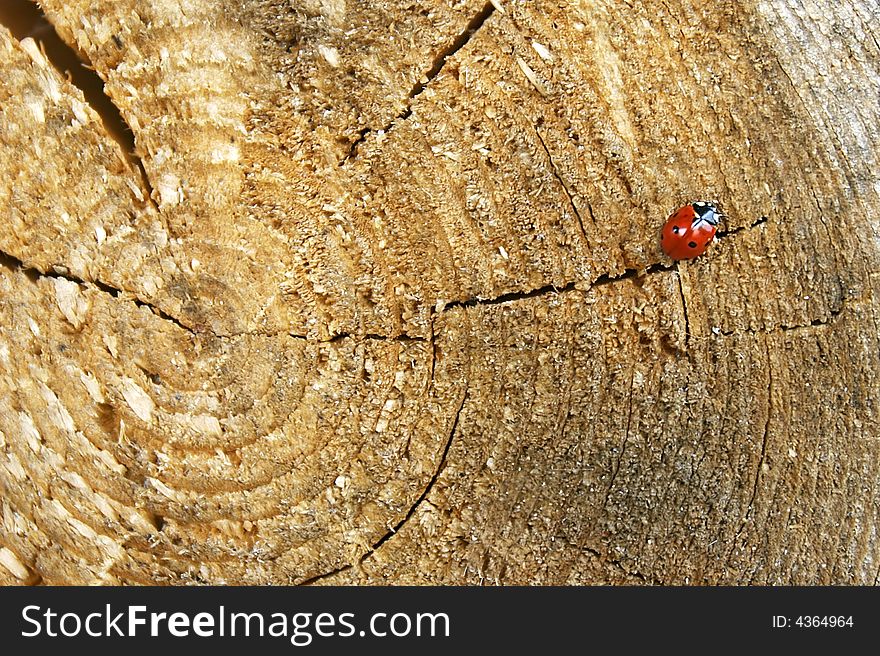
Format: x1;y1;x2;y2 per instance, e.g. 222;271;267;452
0;0;880;585
